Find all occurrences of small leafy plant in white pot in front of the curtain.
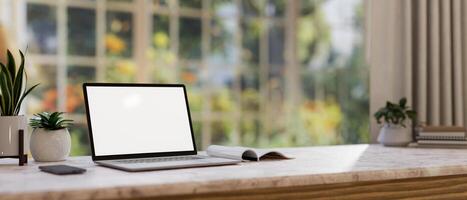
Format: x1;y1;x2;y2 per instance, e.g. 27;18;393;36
374;98;416;146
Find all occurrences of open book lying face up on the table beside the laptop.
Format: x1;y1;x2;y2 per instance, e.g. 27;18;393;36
206;145;290;161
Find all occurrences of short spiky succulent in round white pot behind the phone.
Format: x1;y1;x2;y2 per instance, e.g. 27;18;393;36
29;112;72;162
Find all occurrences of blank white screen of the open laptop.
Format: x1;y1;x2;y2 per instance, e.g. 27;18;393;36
86;86;194;156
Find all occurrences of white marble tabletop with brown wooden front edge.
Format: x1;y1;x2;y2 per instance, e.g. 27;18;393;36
0;145;467;200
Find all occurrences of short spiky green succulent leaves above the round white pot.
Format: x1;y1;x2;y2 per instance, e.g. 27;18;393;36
29;112;73;130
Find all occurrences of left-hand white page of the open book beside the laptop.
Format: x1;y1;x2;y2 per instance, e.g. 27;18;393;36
206;145;258;160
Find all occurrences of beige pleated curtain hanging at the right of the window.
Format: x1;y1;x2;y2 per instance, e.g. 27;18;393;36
365;0;467;141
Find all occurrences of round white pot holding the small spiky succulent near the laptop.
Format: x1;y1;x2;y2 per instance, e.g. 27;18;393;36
31;128;71;162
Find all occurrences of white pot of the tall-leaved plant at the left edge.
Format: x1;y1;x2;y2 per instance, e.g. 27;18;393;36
0;115;29;156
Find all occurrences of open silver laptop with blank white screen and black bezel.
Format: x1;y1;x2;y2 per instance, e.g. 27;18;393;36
83;83;240;171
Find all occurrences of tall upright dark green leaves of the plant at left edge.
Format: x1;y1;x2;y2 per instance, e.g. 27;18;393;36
0;50;39;116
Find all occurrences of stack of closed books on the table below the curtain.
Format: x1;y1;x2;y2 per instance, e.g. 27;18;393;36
415;126;467;148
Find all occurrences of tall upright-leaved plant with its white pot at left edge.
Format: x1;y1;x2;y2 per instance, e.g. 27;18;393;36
0;50;38;157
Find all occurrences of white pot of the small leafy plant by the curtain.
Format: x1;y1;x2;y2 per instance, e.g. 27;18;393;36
378;124;412;146
